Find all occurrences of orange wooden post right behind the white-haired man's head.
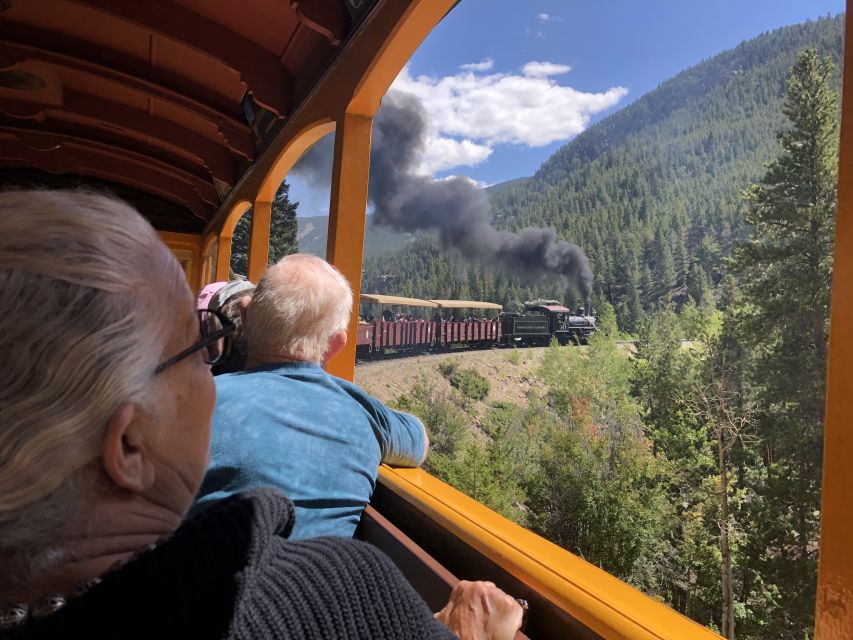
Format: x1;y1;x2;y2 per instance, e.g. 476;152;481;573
326;114;373;380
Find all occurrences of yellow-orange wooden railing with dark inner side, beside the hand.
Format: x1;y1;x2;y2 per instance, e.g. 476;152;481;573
371;466;720;640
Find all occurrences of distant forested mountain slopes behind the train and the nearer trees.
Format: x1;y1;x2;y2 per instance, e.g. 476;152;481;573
363;17;843;331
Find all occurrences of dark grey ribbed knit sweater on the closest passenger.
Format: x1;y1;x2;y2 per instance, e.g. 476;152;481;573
10;489;455;640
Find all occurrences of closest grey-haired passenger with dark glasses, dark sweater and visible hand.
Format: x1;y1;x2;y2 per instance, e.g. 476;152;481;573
0;191;521;638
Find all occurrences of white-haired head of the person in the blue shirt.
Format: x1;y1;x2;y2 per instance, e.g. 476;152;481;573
245;253;352;362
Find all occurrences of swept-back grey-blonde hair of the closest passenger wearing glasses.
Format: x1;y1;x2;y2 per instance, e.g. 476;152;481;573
0;191;180;582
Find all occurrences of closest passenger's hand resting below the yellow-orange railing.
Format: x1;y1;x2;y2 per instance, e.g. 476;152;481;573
435;580;523;640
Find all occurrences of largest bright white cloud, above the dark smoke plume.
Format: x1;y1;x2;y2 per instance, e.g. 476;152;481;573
392;61;628;166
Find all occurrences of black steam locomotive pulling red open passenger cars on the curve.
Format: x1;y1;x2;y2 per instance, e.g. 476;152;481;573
356;294;596;359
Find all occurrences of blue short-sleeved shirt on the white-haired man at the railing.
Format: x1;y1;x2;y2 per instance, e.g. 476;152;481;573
193;362;426;539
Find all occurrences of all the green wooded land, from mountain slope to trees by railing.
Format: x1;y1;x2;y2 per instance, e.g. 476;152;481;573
352;18;843;640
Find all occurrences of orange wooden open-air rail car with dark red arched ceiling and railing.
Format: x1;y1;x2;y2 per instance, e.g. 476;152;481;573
0;0;853;640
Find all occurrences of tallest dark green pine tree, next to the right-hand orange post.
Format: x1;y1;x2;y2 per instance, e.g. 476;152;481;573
734;49;838;639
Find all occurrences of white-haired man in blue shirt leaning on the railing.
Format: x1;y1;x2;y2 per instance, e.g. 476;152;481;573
195;254;428;538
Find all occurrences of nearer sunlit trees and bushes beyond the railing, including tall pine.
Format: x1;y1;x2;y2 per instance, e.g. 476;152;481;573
398;42;839;640
